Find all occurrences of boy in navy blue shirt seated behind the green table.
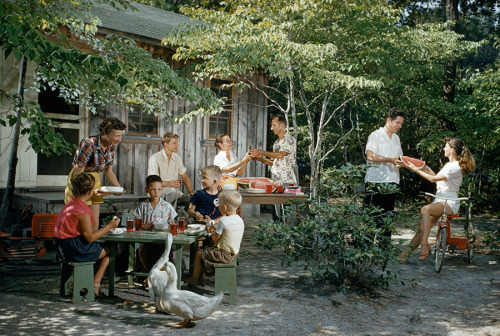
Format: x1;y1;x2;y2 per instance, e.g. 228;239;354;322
187;165;222;223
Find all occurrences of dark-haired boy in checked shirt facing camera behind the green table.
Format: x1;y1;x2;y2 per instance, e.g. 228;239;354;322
134;175;177;272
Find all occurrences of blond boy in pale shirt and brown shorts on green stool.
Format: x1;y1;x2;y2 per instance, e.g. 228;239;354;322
186;190;245;286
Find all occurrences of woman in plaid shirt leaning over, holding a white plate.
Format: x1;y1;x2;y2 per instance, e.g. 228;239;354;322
64;118;126;230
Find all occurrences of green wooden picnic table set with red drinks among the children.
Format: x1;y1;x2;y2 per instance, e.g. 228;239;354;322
99;231;205;296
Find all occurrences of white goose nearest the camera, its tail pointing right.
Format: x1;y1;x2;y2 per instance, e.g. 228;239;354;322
159;260;224;328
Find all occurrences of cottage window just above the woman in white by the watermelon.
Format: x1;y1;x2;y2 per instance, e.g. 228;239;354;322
208;79;233;139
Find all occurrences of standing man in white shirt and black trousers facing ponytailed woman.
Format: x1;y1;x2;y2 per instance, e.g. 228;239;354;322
365;108;404;243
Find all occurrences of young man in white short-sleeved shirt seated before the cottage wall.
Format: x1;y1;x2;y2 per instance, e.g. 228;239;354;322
148;132;194;208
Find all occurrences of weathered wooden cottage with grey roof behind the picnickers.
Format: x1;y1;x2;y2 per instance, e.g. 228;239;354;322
0;4;269;212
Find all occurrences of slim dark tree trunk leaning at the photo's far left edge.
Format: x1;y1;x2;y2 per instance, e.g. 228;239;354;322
0;55;28;231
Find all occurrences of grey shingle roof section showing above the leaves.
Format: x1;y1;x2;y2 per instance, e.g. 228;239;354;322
91;2;200;40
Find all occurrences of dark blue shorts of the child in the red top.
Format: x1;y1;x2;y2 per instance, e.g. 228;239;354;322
55;236;102;262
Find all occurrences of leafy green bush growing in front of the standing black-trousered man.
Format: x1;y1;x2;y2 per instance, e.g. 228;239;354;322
253;164;414;292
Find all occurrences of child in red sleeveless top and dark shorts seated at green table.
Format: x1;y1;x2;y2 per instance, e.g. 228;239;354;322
54;173;120;298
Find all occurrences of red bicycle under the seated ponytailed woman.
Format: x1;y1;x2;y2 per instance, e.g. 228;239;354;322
423;192;472;273
